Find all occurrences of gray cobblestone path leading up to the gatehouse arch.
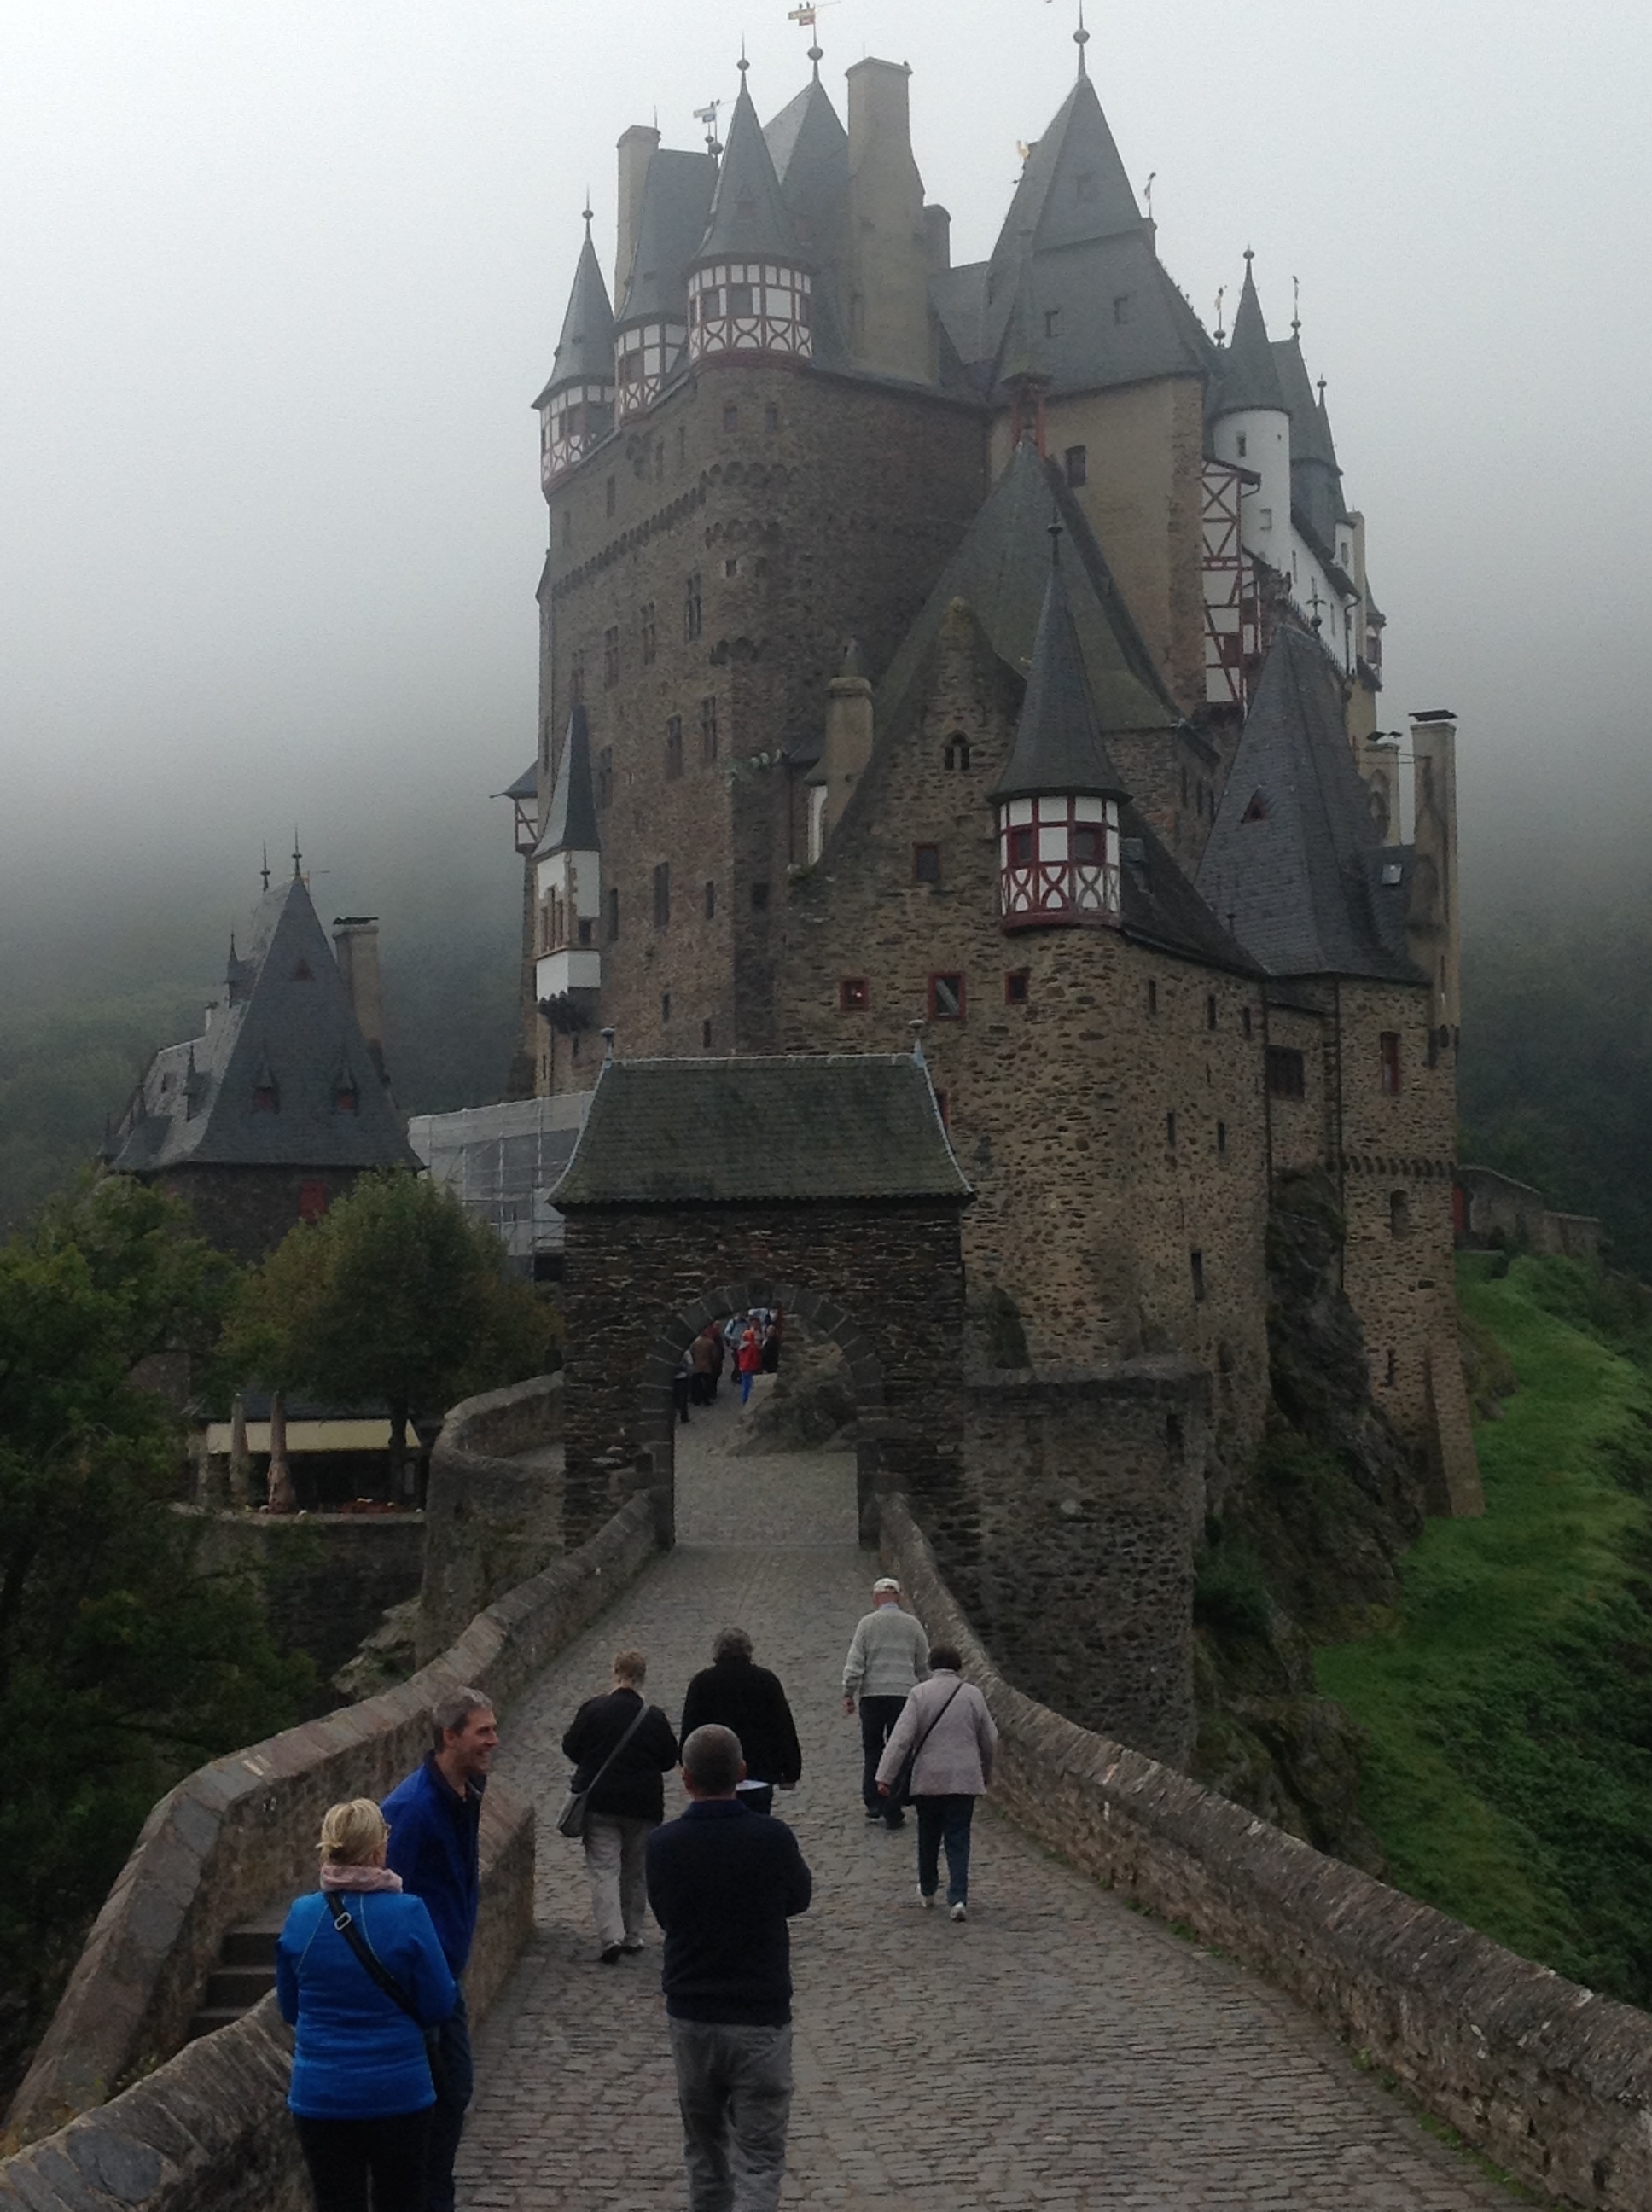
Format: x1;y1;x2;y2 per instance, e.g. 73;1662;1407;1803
460;1394;1513;2212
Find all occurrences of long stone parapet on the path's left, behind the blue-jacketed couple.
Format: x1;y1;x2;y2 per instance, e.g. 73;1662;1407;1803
7;1499;654;2137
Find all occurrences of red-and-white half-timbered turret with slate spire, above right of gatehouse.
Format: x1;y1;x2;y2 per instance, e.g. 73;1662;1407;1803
991;528;1128;929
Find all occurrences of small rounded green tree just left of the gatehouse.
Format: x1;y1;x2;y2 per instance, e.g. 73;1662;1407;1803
225;1168;553;1482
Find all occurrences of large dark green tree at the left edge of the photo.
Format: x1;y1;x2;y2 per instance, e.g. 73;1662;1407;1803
0;1177;310;2077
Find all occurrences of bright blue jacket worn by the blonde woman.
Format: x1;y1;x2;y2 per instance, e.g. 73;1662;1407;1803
276;1889;457;2119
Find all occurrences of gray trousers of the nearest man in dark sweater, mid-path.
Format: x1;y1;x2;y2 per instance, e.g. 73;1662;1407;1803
668;2019;792;2212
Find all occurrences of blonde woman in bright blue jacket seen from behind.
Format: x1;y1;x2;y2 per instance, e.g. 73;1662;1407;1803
276;1798;460;2212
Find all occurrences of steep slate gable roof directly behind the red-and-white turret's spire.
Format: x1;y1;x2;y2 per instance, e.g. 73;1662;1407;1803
875;442;1181;735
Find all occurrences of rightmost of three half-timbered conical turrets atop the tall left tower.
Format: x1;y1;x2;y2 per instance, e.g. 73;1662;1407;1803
688;62;814;360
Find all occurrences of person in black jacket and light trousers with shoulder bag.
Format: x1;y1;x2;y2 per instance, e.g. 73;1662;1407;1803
561;1652;677;1966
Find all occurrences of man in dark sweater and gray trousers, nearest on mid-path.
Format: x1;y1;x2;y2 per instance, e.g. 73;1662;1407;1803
648;1727;814;2212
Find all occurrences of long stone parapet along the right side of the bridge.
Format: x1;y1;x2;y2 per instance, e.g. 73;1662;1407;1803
882;1498;1652;2212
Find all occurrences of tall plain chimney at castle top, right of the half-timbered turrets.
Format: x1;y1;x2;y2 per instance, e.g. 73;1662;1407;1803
847;60;935;385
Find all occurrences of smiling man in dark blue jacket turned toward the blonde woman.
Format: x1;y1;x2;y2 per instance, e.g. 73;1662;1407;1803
382;1690;500;2212
